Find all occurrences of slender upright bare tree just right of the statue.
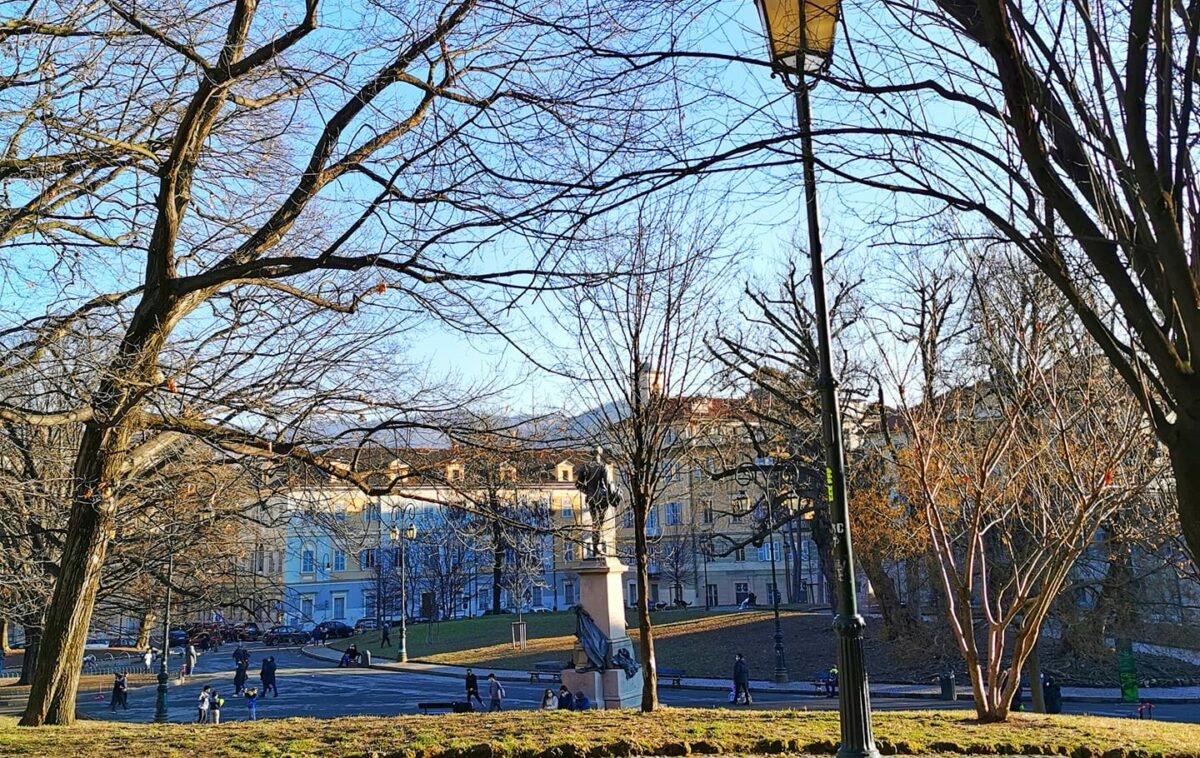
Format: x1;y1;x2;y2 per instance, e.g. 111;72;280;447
564;197;722;711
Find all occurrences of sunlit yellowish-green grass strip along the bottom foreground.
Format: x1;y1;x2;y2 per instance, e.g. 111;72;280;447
0;709;1200;758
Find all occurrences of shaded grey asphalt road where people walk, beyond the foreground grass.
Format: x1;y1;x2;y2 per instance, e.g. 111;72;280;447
78;645;1200;723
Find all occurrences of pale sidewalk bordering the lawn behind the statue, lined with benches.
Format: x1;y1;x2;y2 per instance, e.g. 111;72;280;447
300;645;1200;705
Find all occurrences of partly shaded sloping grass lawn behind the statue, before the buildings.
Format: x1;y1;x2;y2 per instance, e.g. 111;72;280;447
331;609;849;680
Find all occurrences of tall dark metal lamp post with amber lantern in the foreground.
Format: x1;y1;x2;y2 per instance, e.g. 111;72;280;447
755;0;880;758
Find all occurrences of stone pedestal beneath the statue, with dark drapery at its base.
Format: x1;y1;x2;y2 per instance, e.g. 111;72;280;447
563;555;642;708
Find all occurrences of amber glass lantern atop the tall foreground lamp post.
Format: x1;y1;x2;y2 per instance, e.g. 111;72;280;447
755;0;841;77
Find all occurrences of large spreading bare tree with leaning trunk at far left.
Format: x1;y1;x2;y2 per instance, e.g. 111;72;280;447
0;0;696;726
